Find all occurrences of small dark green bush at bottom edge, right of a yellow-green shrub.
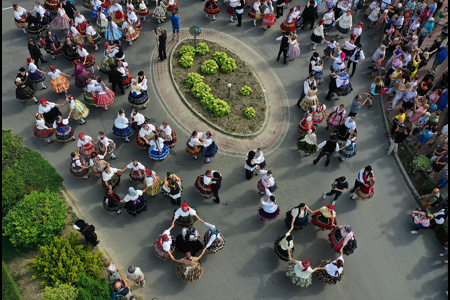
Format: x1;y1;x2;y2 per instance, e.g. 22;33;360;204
77;273;111;300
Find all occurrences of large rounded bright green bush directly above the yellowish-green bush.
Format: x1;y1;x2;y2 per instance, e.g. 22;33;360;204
3;190;67;247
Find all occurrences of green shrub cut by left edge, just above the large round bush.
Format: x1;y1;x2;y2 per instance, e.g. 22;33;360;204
2;168;26;217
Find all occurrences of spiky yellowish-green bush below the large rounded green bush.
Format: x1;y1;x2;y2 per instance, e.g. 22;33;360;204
27;232;103;286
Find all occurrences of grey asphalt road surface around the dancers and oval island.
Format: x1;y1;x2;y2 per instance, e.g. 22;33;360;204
2;0;448;299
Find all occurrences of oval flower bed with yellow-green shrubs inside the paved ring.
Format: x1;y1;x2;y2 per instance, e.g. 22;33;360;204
171;40;267;134
